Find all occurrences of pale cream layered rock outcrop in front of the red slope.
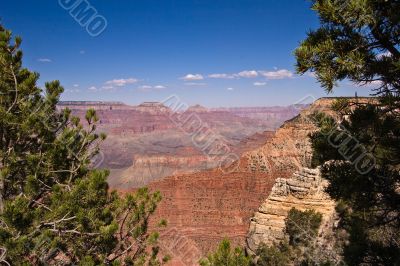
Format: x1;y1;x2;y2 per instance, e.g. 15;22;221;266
247;168;335;254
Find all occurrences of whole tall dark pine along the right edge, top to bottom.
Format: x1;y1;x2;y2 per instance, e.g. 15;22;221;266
296;0;400;265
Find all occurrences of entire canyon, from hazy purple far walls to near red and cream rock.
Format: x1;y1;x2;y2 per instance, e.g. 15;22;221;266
57;98;352;265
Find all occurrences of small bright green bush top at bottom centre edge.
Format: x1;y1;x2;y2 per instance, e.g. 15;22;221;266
200;239;250;266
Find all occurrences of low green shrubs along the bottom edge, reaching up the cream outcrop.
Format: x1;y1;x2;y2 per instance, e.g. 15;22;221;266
200;208;324;266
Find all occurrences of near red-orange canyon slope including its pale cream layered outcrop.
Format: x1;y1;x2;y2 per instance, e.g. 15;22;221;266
141;98;378;265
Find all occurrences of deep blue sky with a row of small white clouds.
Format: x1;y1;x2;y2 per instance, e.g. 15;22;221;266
0;0;370;107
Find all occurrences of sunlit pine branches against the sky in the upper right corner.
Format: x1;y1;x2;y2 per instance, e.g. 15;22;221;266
295;0;400;96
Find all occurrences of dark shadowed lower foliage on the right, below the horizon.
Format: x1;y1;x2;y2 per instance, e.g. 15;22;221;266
311;108;400;264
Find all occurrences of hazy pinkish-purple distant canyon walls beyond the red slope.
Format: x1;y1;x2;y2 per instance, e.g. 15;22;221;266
58;101;305;187
